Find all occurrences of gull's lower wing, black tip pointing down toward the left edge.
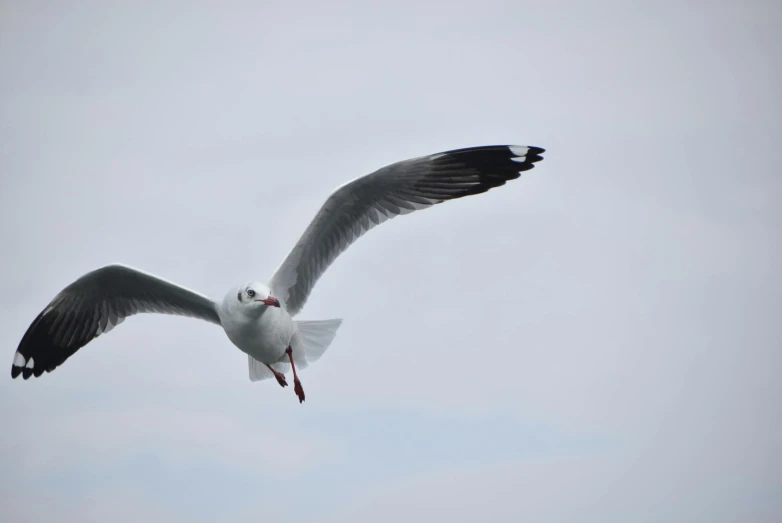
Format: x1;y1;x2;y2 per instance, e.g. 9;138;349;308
11;265;220;379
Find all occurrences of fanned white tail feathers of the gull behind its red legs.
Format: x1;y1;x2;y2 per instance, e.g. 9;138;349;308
247;320;342;381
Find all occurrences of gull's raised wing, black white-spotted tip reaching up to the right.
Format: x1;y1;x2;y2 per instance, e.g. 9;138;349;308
270;145;544;315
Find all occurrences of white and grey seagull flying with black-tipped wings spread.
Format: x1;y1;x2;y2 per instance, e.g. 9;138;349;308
11;145;544;403
